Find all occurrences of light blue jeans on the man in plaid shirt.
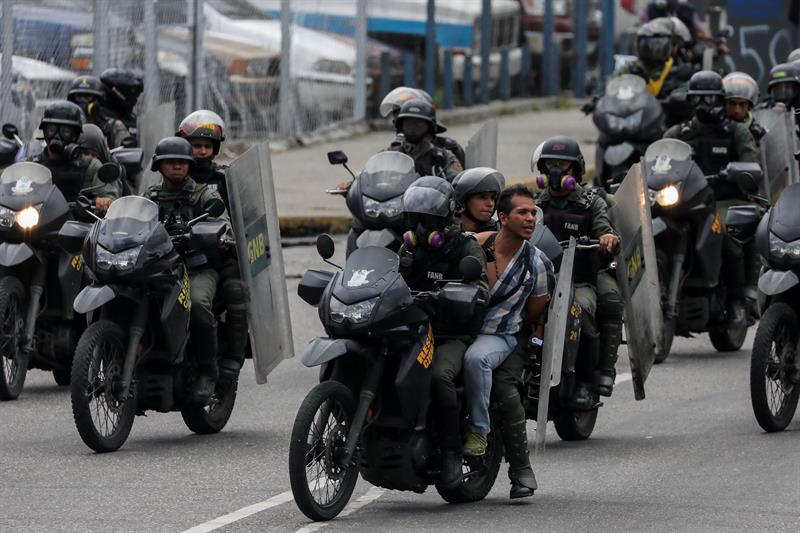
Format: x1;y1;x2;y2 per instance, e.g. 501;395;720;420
464;334;517;433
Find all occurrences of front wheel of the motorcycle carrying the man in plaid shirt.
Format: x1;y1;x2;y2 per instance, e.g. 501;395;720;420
289;381;358;520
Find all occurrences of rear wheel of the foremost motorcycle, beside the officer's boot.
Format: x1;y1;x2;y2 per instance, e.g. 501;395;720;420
436;424;503;503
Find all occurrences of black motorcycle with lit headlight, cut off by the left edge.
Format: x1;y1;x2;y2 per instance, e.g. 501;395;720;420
0;162;119;400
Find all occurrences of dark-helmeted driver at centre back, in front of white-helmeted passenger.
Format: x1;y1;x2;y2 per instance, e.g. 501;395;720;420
389;99;464;181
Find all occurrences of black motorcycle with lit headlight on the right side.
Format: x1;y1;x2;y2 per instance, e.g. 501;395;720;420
643;139;762;363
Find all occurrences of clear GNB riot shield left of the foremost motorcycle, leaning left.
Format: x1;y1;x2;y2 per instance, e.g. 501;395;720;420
226;142;294;383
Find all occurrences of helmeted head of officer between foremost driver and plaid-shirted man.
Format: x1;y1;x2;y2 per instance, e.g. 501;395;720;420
453;167;505;233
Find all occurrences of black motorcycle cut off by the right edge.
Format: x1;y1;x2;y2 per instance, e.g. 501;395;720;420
726;183;800;432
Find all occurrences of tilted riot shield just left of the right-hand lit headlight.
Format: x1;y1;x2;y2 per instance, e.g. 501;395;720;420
611;163;662;400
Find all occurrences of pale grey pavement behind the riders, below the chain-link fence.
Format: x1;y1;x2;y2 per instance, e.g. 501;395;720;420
272;109;596;217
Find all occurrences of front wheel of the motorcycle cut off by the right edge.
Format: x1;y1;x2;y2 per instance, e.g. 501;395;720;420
750;303;800;432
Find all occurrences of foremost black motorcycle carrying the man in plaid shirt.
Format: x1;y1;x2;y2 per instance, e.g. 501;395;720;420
289;235;496;520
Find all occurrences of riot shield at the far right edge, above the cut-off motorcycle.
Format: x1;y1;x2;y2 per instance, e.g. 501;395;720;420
753;107;798;204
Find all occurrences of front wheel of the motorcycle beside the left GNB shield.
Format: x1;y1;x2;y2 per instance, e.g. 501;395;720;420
70;320;136;453
